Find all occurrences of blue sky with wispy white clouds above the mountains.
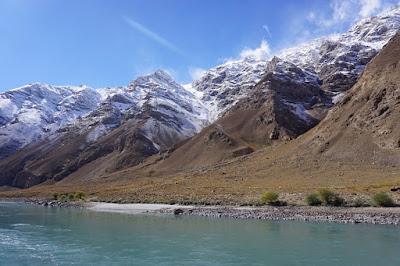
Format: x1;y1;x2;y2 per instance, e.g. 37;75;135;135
0;0;400;91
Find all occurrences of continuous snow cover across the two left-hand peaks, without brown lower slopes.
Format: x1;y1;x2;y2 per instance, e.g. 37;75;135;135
0;71;208;159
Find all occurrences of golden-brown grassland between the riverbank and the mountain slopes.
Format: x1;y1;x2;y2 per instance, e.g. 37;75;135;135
0;141;400;205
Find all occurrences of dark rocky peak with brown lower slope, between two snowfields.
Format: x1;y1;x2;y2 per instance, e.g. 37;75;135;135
155;58;332;169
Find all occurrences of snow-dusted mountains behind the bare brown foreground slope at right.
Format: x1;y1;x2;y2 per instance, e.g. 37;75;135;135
0;8;400;188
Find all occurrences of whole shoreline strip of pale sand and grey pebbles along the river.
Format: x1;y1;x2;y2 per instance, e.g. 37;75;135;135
3;199;400;226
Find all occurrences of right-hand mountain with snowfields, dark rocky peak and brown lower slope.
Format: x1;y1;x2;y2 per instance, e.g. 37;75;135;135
154;8;400;170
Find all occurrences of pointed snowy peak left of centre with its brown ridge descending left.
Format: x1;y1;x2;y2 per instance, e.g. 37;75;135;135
0;71;207;187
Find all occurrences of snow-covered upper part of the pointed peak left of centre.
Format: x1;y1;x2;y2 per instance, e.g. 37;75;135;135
67;70;208;149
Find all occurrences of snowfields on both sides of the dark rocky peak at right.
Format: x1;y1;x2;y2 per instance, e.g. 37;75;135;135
192;7;400;122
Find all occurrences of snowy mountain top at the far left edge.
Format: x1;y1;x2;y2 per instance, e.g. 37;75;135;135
0;83;101;159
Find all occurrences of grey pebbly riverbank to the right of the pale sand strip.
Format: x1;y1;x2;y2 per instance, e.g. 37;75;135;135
157;206;400;225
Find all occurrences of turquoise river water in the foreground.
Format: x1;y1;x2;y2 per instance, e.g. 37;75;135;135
0;202;400;266
